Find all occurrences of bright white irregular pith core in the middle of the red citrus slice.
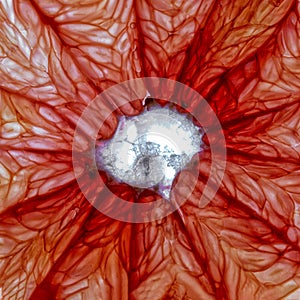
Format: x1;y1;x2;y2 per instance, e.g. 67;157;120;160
96;107;202;199
